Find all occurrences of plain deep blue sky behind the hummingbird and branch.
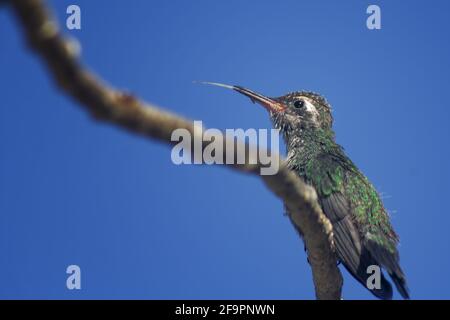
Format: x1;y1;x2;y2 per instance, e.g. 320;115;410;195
0;0;450;299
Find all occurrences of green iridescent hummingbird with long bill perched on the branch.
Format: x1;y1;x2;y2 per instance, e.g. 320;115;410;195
203;82;409;299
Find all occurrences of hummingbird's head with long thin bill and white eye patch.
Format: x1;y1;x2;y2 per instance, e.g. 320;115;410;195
204;82;333;138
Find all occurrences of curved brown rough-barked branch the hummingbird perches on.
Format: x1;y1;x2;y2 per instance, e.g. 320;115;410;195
6;0;342;299
